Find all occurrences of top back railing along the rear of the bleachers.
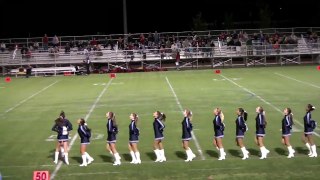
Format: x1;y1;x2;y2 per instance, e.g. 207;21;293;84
0;27;320;50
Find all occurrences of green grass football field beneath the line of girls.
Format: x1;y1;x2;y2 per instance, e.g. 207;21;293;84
0;66;320;180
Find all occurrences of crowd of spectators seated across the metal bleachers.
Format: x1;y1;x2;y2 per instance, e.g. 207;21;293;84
0;28;318;58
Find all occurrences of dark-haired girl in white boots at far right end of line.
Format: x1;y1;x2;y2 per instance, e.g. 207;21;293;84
303;104;318;157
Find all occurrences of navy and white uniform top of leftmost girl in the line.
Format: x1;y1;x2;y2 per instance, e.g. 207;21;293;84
51;119;72;142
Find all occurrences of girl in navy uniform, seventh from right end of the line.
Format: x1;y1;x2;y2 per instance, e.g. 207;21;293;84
153;111;167;162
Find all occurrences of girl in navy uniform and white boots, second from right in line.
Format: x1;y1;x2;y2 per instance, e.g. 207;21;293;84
281;108;295;158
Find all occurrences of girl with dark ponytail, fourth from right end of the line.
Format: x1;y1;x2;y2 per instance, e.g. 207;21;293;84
236;108;249;160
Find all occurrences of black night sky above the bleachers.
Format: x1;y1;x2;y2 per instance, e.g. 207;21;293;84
0;0;320;38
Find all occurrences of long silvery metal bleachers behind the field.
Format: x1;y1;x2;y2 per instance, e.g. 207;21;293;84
0;28;320;75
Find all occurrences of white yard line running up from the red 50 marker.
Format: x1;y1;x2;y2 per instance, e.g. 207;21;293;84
50;78;113;180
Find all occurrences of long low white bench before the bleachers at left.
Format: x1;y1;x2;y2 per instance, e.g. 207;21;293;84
10;67;76;77
